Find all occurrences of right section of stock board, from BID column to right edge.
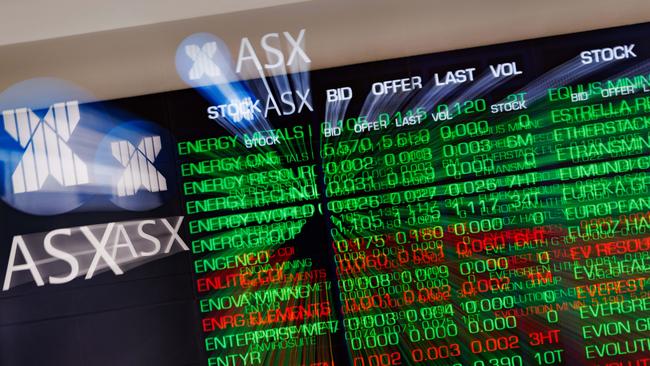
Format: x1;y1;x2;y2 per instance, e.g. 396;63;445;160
320;31;650;366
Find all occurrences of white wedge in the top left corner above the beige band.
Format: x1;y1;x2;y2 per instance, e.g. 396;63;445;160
0;0;308;46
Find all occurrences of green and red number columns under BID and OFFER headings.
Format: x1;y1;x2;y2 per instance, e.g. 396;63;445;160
321;63;450;365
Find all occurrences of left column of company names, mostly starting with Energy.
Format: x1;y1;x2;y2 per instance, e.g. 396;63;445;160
172;88;339;365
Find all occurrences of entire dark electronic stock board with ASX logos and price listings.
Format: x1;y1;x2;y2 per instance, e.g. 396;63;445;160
0;24;650;366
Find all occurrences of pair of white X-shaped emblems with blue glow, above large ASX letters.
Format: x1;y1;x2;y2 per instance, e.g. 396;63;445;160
0;100;171;215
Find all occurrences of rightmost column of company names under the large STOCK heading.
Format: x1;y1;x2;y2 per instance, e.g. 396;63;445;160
536;35;650;365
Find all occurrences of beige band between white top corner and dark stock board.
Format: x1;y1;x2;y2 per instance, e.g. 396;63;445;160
0;0;650;99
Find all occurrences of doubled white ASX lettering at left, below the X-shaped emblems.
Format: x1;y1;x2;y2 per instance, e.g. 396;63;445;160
2;216;189;291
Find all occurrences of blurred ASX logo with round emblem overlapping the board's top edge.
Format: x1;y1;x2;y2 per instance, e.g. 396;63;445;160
176;29;314;123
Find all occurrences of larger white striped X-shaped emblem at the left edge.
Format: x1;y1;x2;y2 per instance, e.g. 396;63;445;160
2;101;89;194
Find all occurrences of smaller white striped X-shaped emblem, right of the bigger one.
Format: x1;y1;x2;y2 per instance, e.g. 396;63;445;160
111;136;167;197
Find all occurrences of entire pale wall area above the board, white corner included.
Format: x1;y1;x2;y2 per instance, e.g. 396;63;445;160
0;0;650;100
